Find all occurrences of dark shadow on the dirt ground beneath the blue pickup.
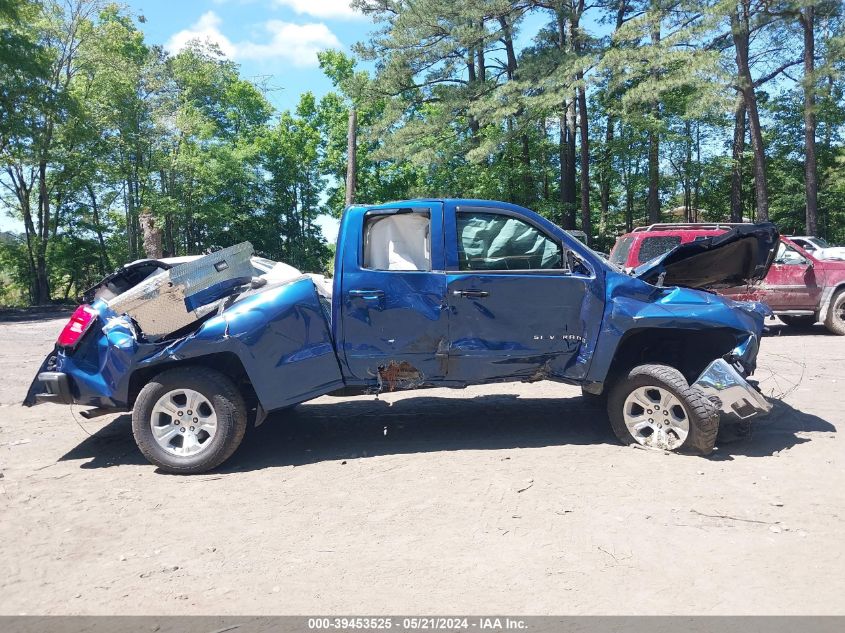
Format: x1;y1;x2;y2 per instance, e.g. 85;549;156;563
61;394;836;473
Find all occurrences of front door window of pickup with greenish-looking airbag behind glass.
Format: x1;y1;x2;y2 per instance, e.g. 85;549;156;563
457;211;564;270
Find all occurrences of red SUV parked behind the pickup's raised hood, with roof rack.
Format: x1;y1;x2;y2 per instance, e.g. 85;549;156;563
610;223;845;335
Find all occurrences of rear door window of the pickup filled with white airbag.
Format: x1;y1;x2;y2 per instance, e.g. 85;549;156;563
364;213;431;271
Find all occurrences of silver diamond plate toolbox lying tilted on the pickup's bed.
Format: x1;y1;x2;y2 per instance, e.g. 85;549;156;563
109;242;253;341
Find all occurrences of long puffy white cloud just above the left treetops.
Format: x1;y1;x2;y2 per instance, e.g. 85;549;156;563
165;11;343;66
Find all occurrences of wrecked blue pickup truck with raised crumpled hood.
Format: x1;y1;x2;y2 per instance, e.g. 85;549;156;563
25;200;778;473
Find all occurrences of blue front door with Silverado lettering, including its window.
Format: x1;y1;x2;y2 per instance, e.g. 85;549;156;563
446;206;604;382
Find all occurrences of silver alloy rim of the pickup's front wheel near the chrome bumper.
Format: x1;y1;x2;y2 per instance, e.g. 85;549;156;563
623;387;689;451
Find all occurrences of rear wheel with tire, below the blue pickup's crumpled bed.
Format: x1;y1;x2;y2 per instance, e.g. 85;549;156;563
132;367;247;474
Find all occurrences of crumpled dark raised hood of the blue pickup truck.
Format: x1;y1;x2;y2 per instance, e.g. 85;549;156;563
631;222;780;288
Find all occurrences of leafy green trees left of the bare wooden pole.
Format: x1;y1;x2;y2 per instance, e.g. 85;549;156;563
0;0;334;303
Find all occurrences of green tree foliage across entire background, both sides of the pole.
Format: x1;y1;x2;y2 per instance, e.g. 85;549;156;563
0;0;845;303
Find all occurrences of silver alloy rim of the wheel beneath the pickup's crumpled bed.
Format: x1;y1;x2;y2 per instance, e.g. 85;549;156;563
150;389;217;457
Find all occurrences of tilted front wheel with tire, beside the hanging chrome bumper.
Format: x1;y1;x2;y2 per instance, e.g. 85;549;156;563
607;365;719;455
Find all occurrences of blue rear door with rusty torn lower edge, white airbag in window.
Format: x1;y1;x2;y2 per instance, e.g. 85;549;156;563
336;202;448;391
